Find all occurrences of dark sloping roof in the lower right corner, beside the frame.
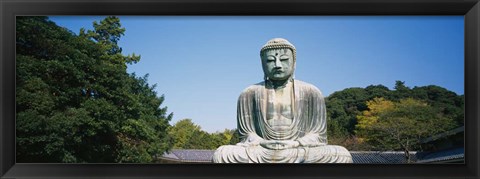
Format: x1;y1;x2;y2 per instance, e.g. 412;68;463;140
417;147;465;163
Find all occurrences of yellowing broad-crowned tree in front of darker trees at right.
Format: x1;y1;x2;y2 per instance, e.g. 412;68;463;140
356;98;454;161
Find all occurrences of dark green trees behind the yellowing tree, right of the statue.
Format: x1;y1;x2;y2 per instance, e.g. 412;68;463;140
325;81;465;150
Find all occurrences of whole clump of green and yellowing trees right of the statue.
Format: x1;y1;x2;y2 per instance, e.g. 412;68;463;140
326;81;464;150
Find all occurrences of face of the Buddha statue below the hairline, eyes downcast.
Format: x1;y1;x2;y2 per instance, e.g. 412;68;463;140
261;48;295;80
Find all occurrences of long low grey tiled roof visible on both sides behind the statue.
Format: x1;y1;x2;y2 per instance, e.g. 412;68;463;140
162;149;417;164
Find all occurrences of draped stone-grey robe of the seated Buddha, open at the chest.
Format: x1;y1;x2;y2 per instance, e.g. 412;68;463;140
213;80;352;163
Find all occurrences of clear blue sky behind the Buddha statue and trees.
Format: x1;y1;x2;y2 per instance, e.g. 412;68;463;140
50;16;464;132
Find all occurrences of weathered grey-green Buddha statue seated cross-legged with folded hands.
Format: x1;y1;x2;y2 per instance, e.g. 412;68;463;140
213;38;352;163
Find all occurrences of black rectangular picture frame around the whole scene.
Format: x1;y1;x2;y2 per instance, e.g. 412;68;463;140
0;0;480;179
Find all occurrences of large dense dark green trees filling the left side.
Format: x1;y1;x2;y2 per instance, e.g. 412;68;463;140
16;16;173;162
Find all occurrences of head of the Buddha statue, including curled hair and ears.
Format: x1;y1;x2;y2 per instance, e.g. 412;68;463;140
260;38;296;81
